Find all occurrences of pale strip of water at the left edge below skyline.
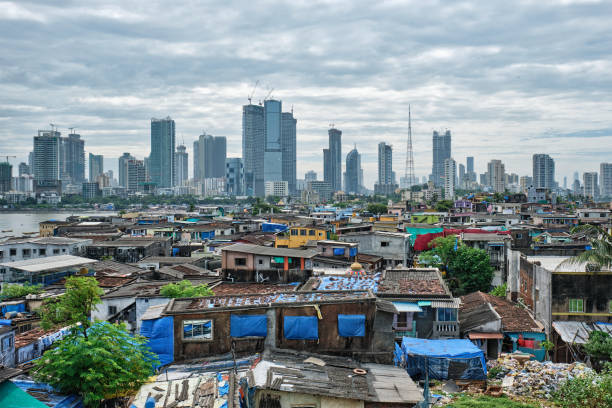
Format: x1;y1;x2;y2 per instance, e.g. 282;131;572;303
0;211;116;237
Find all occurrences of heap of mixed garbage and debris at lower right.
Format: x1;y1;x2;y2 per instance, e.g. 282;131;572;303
495;354;592;399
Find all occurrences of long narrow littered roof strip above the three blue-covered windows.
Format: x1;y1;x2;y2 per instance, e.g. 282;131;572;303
164;291;376;314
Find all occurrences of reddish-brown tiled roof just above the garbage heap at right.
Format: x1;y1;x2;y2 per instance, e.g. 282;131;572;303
460;292;542;332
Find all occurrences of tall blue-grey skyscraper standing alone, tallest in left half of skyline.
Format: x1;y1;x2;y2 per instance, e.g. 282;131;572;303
149;116;176;188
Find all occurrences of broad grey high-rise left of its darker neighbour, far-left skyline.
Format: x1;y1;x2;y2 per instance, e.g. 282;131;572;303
34;130;61;184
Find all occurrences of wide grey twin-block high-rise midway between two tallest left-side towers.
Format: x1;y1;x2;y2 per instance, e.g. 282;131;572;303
193;133;227;180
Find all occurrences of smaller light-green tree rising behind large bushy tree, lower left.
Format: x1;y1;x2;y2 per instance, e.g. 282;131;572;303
41;276;104;338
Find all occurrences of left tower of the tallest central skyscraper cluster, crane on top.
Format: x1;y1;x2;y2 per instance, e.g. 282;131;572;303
242;104;265;197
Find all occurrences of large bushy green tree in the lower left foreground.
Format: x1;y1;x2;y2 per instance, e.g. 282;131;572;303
33;322;159;407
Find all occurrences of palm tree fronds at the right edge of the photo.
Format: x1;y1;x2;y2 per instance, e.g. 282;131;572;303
562;224;612;269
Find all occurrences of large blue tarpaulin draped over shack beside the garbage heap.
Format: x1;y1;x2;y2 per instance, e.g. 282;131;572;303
396;337;487;380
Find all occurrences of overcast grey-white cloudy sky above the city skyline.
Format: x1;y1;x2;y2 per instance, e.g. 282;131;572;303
0;0;612;187
